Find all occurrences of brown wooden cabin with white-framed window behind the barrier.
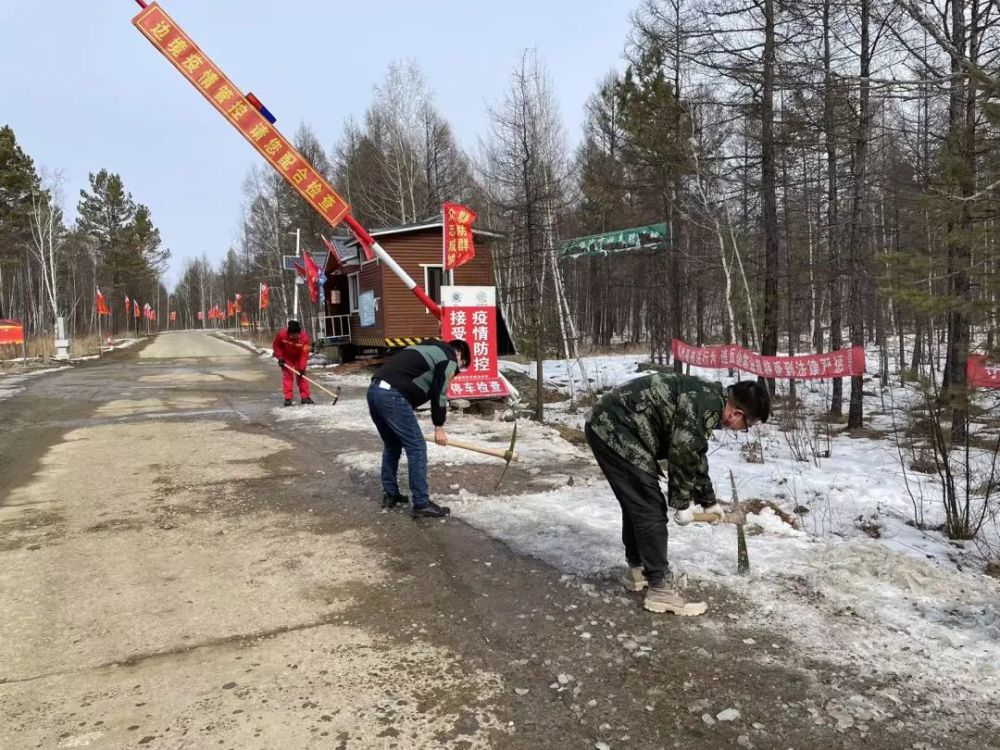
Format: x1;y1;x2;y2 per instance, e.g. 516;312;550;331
314;218;506;362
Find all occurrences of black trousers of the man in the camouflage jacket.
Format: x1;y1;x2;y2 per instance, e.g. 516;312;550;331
584;424;670;586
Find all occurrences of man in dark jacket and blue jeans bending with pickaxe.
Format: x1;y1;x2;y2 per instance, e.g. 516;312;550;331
368;339;470;518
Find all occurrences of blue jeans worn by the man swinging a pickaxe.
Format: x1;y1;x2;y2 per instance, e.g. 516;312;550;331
368;383;430;508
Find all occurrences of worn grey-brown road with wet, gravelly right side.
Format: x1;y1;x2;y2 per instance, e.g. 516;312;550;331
0;333;984;750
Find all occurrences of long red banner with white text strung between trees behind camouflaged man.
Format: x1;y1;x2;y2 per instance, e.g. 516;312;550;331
672;339;865;380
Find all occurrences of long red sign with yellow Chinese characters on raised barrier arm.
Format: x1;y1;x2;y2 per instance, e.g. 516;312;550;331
132;3;350;232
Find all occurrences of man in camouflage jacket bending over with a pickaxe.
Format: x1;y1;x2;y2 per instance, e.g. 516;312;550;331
585;373;770;615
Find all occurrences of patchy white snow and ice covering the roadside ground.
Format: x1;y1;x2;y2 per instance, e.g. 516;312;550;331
292;355;1000;721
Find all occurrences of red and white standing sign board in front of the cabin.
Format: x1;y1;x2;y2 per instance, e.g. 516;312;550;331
441;286;510;399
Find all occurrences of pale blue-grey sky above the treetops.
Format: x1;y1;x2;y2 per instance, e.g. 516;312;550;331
0;0;638;285
